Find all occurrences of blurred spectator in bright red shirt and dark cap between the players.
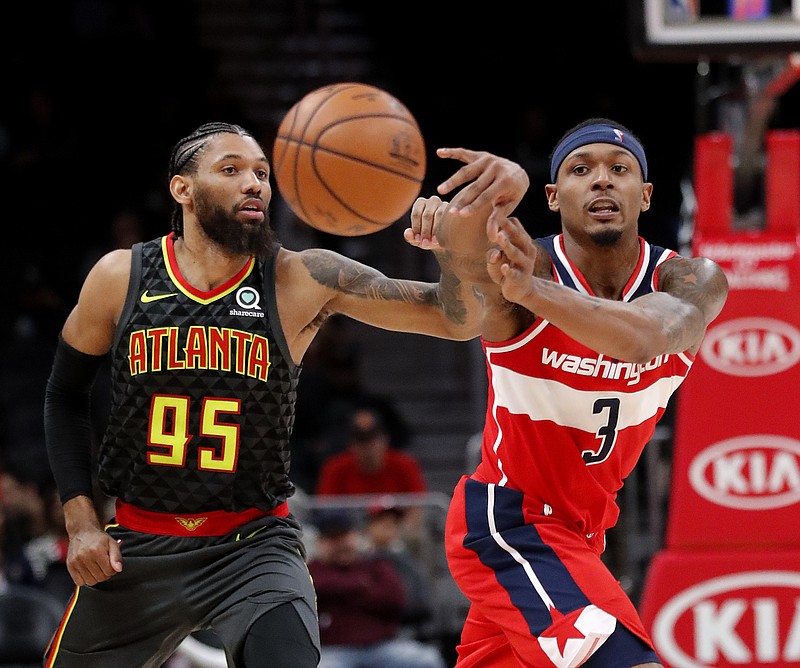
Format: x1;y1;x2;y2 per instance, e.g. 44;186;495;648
316;407;428;538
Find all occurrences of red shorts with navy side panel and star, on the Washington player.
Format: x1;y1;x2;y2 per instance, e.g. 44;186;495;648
446;476;658;668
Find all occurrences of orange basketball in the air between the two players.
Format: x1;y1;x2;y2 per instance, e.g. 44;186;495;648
272;83;425;237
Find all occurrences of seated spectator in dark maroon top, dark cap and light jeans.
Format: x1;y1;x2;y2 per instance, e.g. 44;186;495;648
308;510;445;668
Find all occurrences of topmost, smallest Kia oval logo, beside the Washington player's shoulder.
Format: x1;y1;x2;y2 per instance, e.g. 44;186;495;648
700;318;800;376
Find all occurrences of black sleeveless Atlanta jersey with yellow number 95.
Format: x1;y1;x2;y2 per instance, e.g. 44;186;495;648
98;235;300;513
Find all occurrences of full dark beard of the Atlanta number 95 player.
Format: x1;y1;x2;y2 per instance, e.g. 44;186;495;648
195;193;275;260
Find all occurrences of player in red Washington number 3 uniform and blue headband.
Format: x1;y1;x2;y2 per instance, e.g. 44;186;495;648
406;118;727;668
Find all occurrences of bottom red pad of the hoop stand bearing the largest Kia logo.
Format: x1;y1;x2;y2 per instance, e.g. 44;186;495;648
640;550;800;668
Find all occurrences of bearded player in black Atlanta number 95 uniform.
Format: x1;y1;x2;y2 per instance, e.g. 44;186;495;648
45;123;528;668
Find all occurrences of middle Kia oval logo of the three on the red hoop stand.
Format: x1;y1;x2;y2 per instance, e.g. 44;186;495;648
688;434;800;510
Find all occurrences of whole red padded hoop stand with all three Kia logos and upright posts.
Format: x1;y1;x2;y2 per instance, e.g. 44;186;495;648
639;131;800;668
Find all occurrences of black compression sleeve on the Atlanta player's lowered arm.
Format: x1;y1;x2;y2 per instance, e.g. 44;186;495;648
44;335;105;503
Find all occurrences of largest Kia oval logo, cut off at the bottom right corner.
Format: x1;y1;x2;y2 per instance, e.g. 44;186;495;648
652;571;800;668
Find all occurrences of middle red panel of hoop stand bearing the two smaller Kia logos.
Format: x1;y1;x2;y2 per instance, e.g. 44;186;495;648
666;235;800;549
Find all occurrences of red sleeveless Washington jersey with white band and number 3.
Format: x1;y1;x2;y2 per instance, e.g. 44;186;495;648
473;235;694;550
